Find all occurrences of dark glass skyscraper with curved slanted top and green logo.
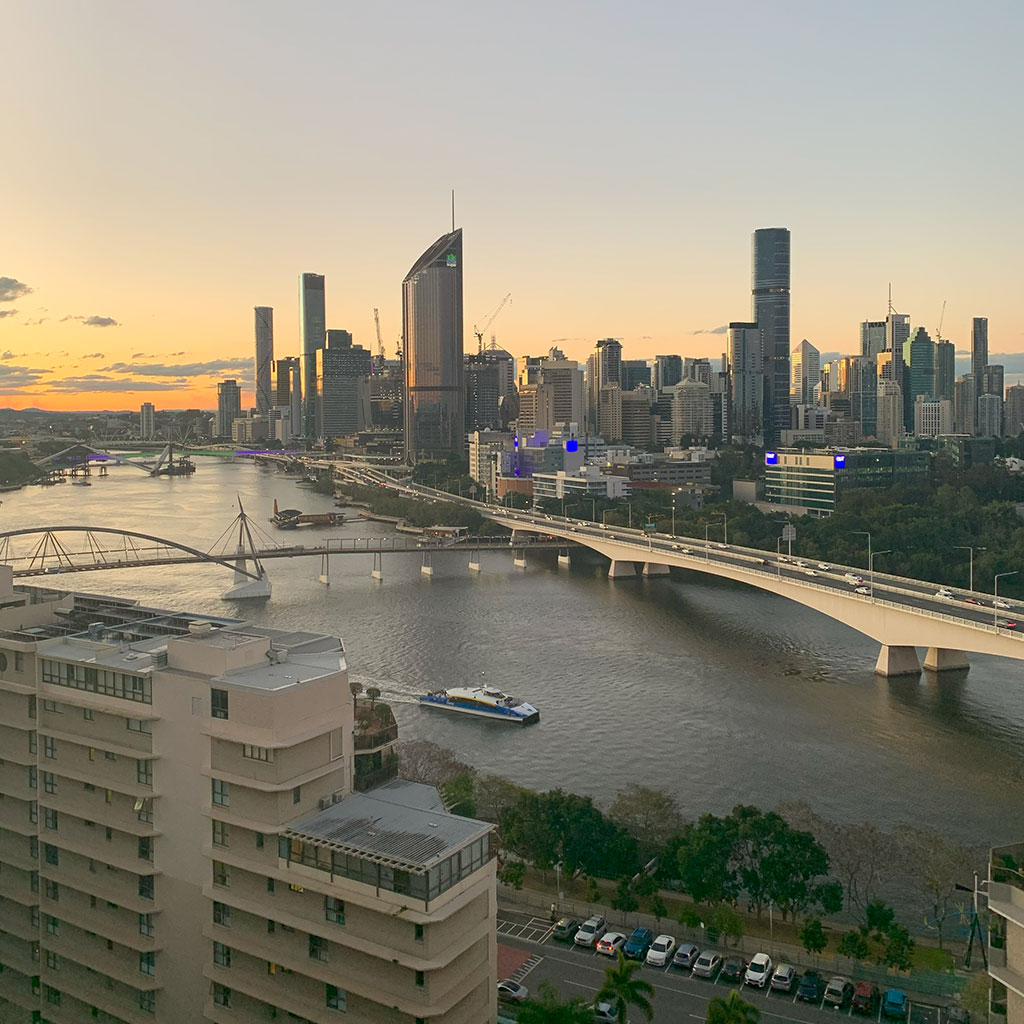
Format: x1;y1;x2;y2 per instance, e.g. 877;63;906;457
401;227;466;461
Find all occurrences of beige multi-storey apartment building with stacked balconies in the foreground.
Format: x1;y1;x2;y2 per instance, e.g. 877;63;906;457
0;569;497;1024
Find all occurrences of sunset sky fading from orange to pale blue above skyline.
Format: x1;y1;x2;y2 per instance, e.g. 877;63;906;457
0;0;1024;410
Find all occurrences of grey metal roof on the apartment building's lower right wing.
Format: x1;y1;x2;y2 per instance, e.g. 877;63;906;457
285;779;494;873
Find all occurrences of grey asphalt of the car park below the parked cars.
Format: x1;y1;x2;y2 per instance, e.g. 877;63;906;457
498;908;946;1024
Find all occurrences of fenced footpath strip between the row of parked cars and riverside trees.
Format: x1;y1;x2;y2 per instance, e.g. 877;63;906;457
498;884;981;1004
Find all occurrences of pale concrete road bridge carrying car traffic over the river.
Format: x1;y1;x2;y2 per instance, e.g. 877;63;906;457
340;466;1024;677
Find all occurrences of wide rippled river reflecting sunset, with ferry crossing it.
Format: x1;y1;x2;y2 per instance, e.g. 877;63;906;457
8;458;1024;845
